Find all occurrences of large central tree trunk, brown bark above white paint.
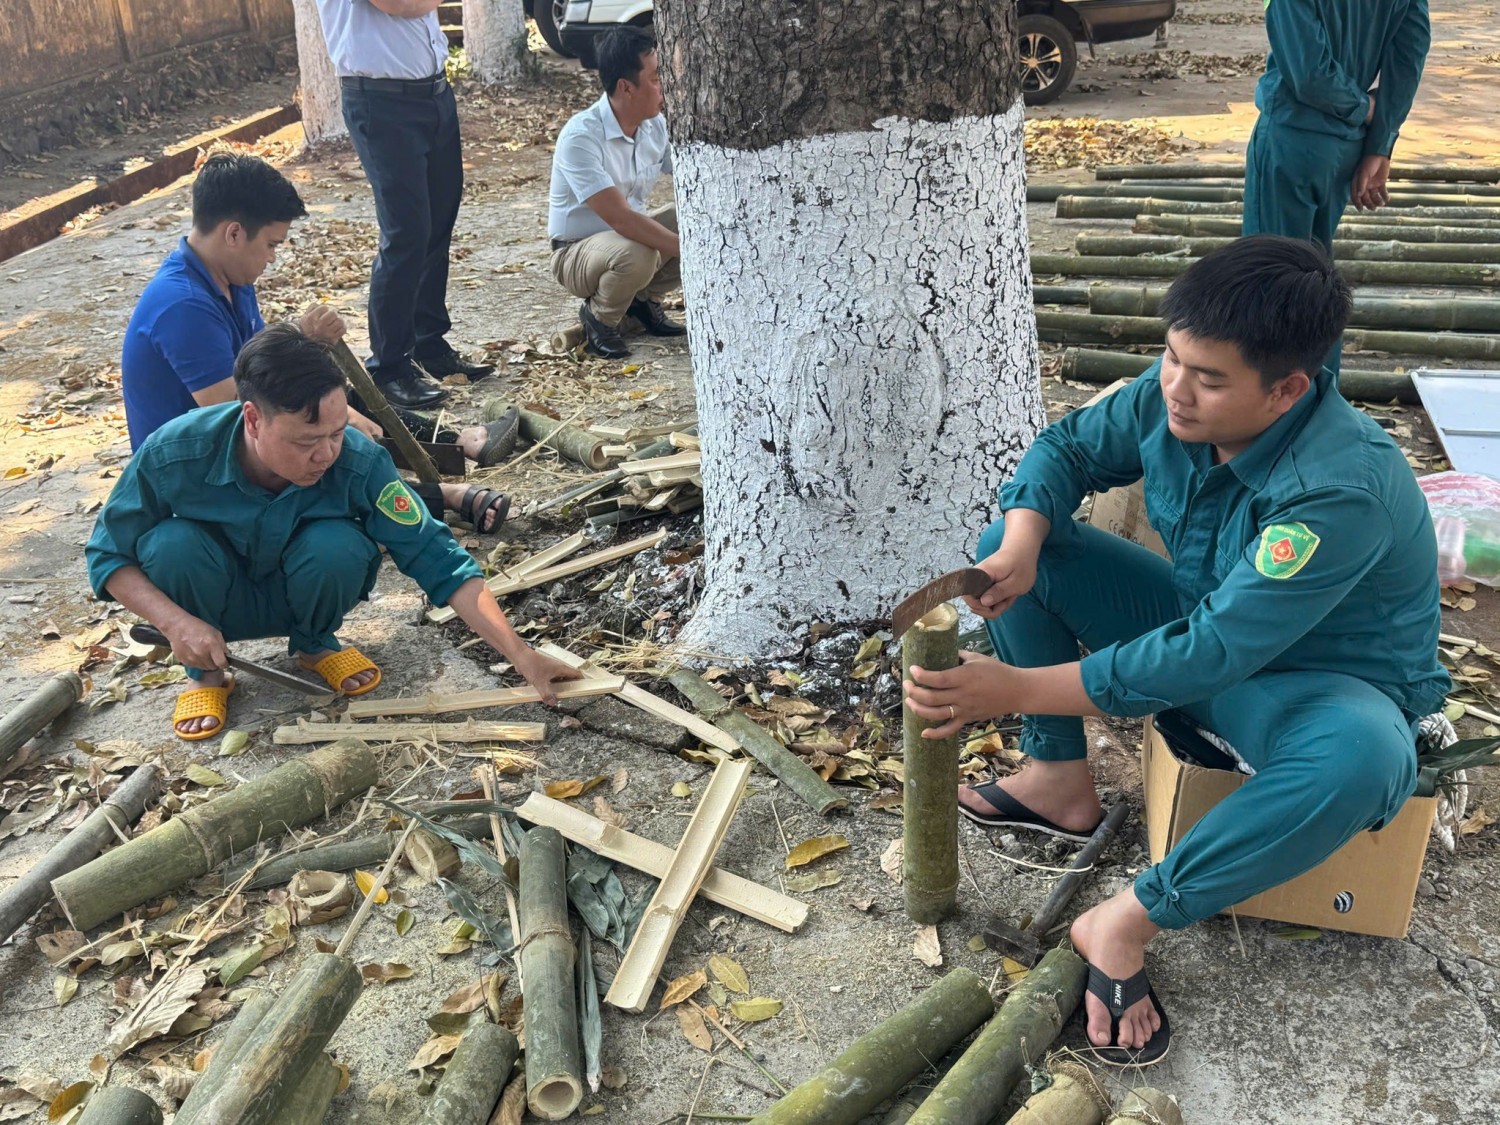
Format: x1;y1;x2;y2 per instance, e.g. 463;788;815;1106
656;0;1044;656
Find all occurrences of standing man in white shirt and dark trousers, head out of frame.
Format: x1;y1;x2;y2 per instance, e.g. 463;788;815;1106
318;0;494;410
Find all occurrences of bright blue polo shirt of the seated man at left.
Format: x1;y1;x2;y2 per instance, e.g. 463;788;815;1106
120;239;266;450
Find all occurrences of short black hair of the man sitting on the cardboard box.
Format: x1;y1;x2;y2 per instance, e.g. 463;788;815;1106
1161;234;1355;390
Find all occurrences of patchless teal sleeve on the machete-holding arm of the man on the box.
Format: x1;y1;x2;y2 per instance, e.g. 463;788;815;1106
1001;375;1161;528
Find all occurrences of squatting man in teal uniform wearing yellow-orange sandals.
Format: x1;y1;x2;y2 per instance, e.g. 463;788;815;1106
86;324;578;740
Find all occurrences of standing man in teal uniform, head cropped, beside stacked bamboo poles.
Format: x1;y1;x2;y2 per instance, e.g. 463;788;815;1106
1244;0;1431;254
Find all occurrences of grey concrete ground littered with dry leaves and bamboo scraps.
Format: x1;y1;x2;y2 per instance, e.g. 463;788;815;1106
0;0;1500;1125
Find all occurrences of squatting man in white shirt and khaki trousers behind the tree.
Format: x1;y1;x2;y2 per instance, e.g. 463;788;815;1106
549;27;687;359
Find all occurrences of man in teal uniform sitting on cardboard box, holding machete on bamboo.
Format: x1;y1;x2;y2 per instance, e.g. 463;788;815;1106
906;238;1449;1064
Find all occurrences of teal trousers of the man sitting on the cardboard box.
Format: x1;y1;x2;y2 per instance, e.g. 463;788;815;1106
978;521;1416;929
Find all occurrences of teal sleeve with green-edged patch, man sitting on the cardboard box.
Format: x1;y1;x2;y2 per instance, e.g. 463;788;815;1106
1082;488;1395;716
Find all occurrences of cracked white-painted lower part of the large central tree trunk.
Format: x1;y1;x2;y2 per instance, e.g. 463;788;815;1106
674;102;1046;657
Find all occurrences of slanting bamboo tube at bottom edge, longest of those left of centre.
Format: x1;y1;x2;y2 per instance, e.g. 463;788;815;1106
173;953;362;1125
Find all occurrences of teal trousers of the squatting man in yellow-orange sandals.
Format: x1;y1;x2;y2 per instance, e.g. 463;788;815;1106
137;518;381;680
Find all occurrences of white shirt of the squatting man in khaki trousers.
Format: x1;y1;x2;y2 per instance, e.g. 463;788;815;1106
548;95;672;242
